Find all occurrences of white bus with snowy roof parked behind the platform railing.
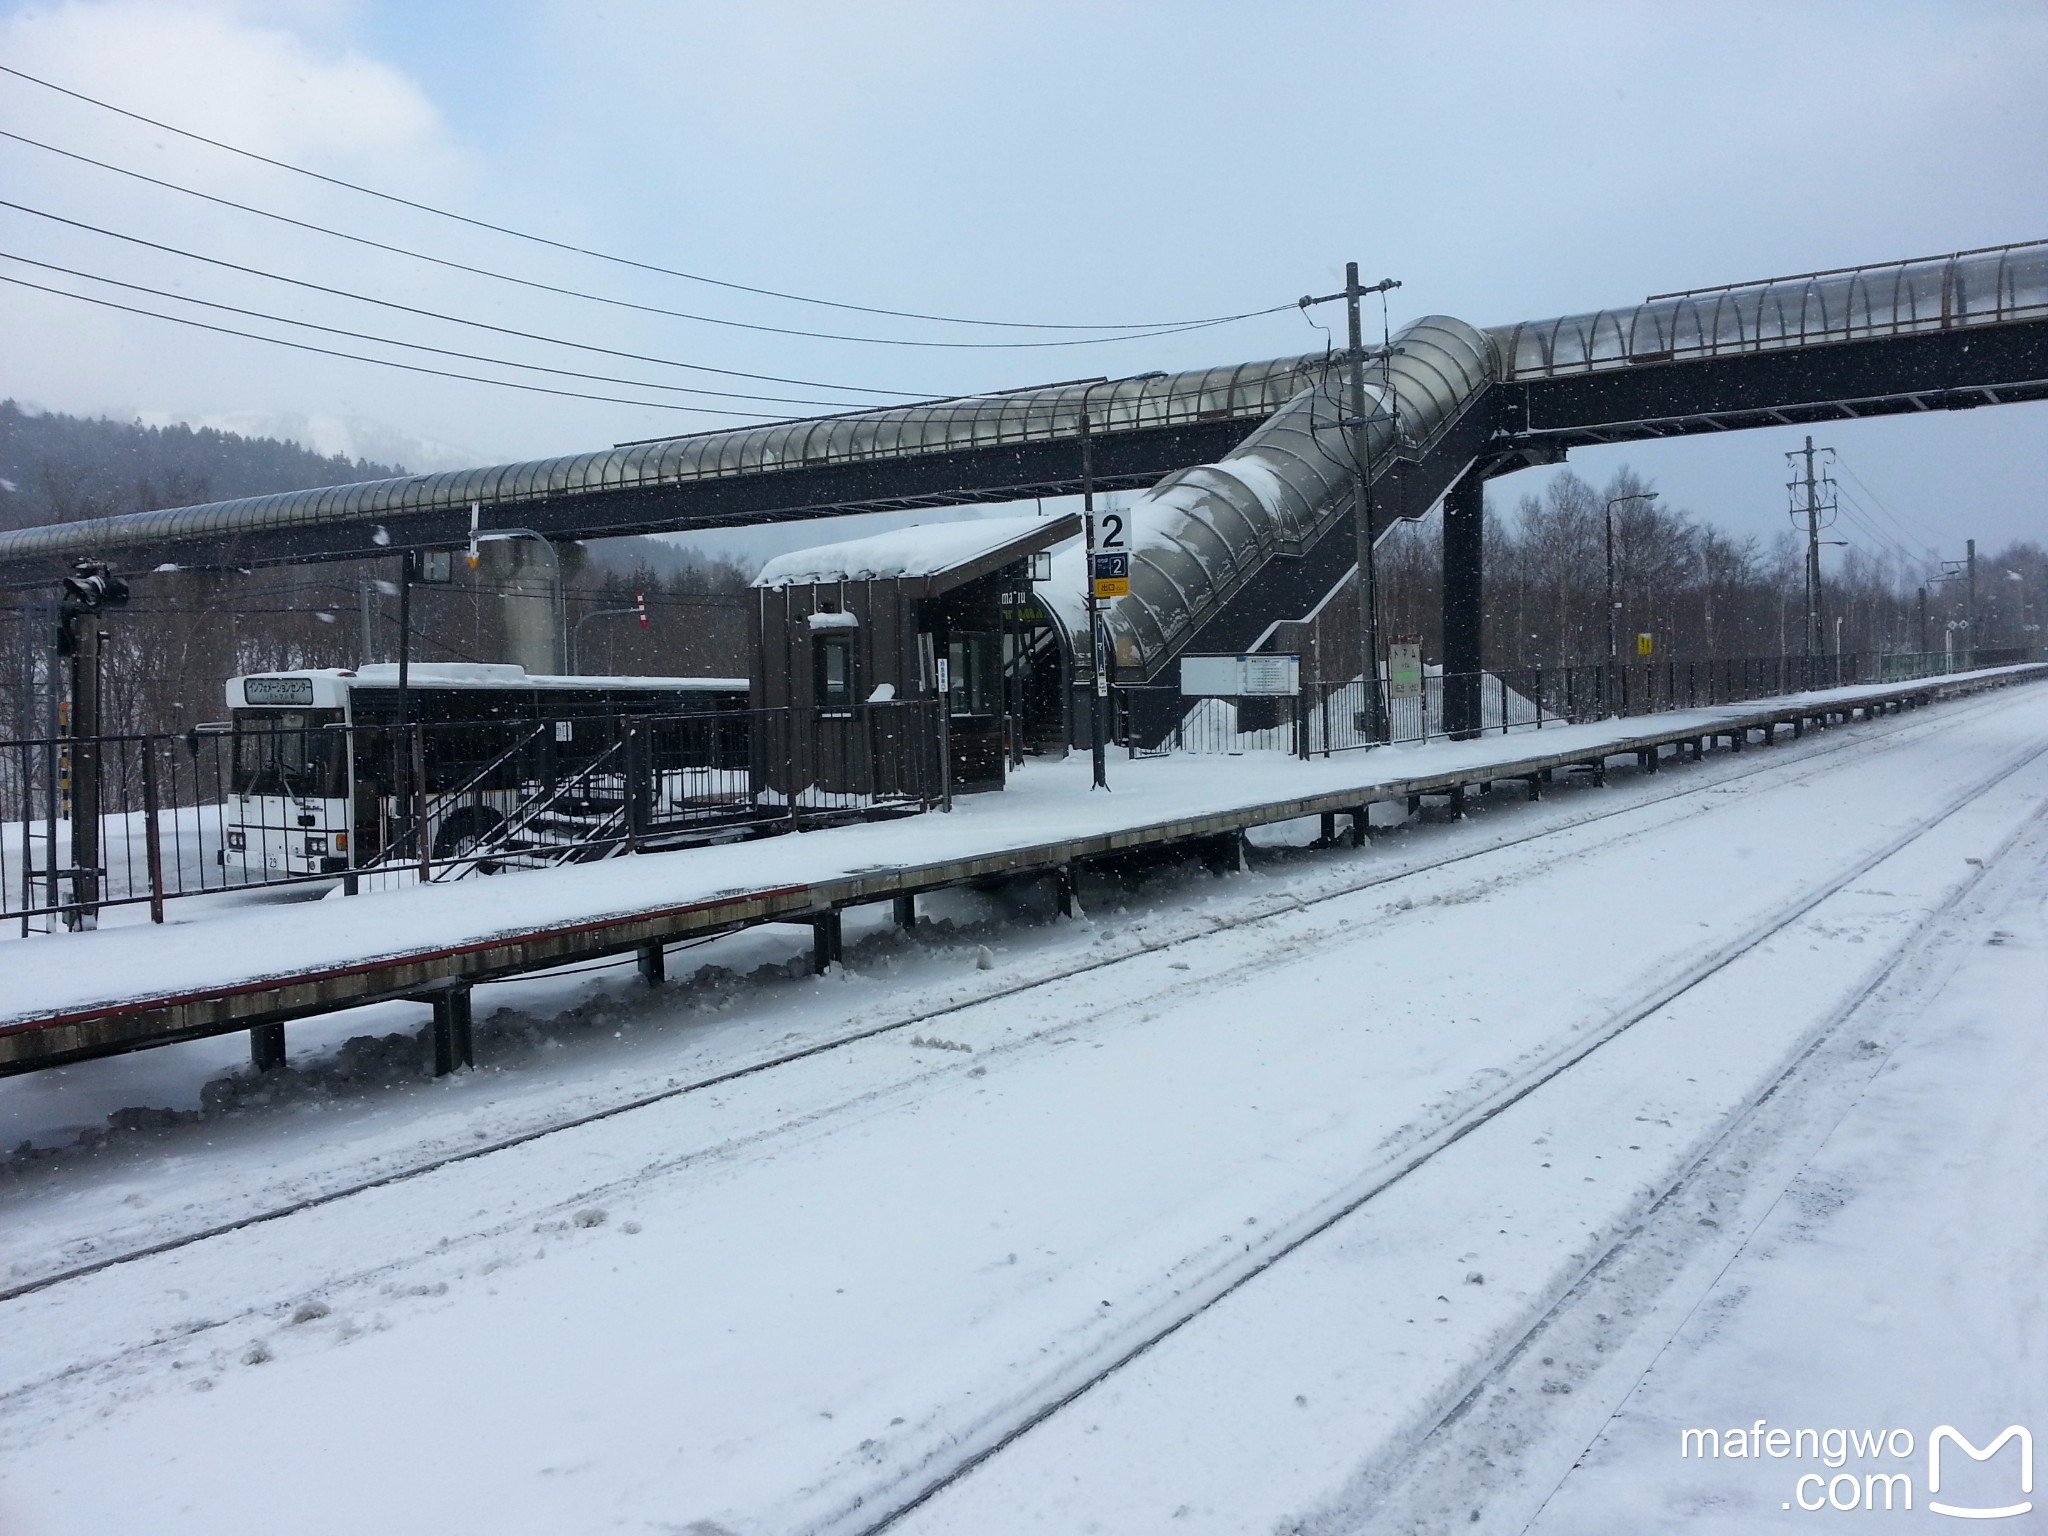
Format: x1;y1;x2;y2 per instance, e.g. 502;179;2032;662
220;662;748;883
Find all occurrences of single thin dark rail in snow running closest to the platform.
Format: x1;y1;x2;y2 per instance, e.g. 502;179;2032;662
0;696;2003;1307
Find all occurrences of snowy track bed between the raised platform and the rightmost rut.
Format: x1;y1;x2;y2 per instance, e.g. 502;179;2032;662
0;700;2048;1536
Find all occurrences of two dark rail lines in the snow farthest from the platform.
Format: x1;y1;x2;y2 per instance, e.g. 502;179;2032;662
831;720;2048;1536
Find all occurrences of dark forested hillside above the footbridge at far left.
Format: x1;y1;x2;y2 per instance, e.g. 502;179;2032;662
0;399;408;528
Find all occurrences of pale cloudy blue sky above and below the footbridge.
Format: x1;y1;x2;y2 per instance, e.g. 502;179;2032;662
0;0;2048;569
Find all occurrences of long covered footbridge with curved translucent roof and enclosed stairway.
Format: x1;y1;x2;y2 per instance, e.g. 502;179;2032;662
0;242;2048;741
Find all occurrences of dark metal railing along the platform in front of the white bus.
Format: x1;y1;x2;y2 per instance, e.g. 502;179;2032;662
0;698;950;934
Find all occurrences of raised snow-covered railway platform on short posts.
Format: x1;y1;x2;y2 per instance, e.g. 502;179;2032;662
0;666;2048;1075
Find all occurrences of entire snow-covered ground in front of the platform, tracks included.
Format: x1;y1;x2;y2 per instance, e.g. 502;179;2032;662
0;690;2048;1536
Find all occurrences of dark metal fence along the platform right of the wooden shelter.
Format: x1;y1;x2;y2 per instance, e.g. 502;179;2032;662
1120;647;2038;758
